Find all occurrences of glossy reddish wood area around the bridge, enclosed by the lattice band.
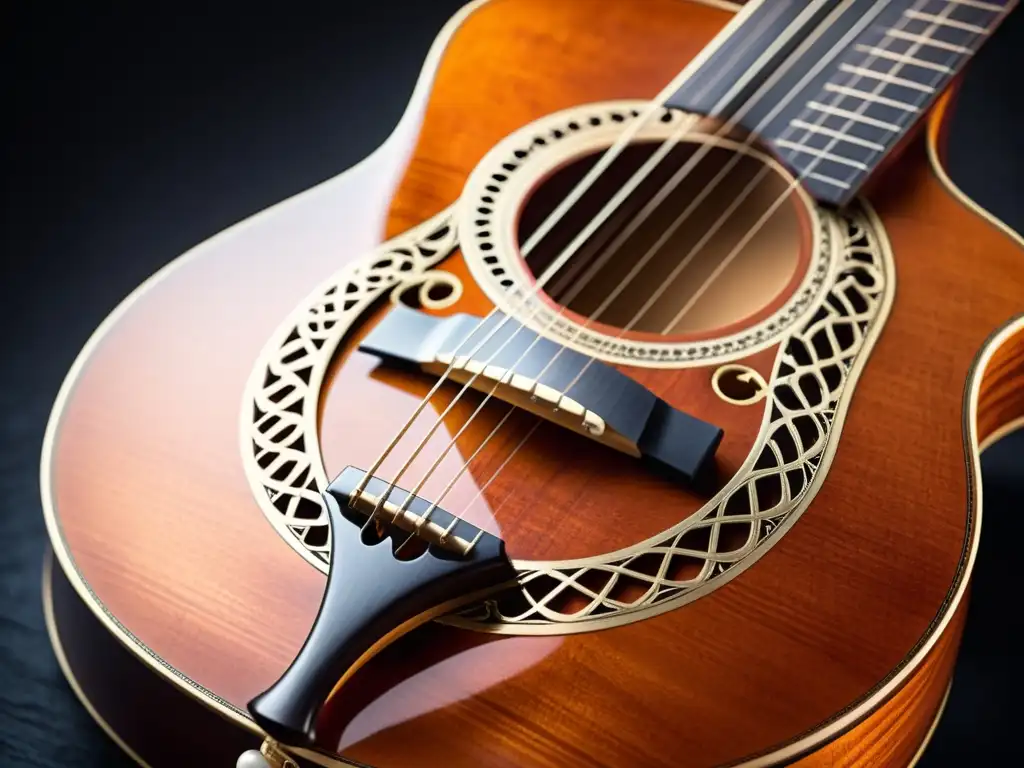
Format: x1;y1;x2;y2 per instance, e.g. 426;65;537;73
321;327;777;560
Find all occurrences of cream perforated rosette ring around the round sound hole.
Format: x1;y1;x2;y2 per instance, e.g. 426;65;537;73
459;101;833;368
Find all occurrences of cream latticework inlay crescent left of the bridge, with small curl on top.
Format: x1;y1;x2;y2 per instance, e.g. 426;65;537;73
242;209;462;565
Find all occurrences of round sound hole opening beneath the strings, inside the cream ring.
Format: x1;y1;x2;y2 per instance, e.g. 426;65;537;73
518;142;810;339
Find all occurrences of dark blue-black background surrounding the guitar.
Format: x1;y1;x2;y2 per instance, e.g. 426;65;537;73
0;0;1024;768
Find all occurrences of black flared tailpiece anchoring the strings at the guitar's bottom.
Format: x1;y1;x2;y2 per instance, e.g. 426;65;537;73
249;467;515;748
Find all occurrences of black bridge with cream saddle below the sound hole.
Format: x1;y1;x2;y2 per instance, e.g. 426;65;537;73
359;306;723;484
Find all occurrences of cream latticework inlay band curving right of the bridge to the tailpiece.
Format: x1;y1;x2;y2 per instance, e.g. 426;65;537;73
456;207;892;631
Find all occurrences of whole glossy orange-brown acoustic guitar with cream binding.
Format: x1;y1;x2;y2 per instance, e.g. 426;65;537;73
42;0;1024;768
